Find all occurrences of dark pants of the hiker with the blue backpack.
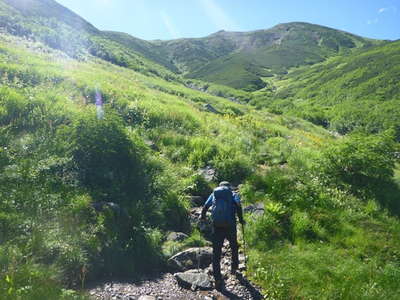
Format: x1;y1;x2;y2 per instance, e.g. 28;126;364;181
212;225;239;280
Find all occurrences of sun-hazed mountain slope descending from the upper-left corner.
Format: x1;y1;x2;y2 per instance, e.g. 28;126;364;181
0;0;177;79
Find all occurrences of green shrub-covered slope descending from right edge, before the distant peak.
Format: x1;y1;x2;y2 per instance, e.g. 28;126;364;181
254;41;400;136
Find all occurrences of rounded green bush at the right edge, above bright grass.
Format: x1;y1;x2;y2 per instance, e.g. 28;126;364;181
317;133;396;197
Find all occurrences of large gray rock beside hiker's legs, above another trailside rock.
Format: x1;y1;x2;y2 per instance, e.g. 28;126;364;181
168;247;212;271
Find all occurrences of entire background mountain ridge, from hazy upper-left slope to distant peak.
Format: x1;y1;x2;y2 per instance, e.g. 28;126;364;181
0;0;381;91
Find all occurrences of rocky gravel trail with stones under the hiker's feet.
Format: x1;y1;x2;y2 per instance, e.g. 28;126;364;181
89;203;263;300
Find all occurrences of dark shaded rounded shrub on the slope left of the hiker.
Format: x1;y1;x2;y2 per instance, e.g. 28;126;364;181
70;112;149;203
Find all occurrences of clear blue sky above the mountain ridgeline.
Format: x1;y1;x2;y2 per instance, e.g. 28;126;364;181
57;0;400;40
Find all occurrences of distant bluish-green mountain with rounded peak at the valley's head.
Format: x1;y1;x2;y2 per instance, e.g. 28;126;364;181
149;22;377;90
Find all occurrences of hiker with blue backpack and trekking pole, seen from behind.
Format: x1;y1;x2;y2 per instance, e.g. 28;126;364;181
201;181;245;290
